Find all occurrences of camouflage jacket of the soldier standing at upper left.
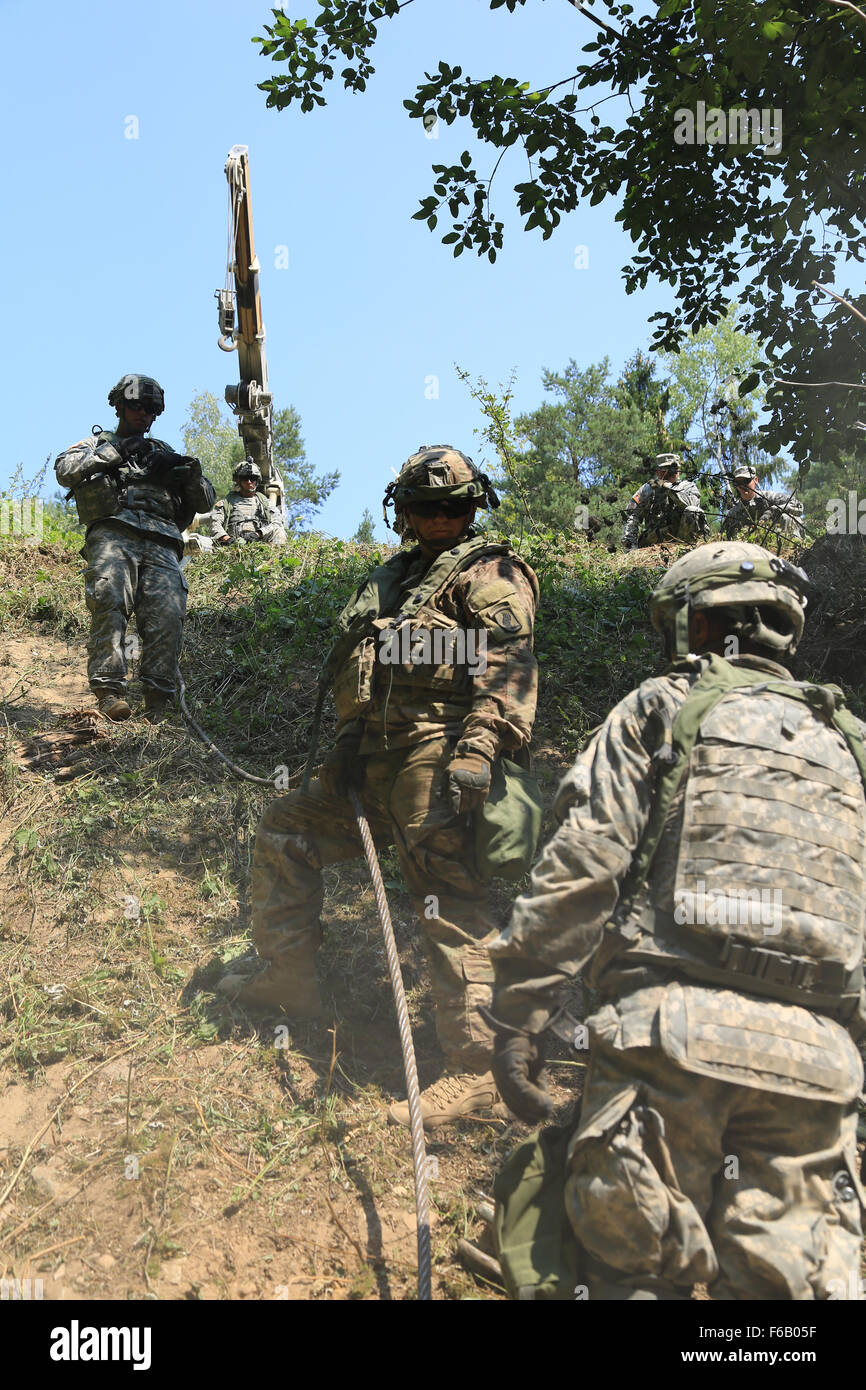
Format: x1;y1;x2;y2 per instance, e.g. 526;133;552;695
54;430;215;555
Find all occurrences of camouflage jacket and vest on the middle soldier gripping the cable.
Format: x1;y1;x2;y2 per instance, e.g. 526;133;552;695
334;537;538;760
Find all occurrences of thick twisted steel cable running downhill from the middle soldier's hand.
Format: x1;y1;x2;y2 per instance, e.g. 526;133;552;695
349;787;432;1302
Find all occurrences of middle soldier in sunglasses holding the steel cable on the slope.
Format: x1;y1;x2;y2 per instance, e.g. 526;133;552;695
220;446;538;1129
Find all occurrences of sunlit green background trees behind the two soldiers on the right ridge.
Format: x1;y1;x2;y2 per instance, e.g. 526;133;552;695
459;309;781;548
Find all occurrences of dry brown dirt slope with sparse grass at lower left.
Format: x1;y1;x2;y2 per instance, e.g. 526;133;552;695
0;606;577;1300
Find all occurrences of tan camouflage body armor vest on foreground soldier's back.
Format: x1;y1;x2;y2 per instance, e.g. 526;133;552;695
592;656;866;1019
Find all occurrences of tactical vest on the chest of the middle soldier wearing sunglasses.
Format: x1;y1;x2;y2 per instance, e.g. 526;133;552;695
327;535;538;721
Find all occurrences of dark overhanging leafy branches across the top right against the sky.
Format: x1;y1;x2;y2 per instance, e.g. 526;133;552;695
253;0;866;461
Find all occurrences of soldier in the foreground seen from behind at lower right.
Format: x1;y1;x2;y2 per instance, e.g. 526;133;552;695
491;543;866;1300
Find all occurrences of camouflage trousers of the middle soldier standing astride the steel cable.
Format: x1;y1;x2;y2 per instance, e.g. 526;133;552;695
252;738;499;1072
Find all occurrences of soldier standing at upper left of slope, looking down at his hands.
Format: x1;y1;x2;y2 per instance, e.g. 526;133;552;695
54;373;215;723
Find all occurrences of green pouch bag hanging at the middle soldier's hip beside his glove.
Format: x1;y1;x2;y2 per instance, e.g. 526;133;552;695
475;758;544;880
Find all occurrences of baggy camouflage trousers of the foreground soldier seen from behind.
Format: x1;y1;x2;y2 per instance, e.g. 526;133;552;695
566;1008;866;1300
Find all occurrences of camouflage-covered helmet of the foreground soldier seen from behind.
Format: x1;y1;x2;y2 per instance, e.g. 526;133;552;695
649;541;809;659
